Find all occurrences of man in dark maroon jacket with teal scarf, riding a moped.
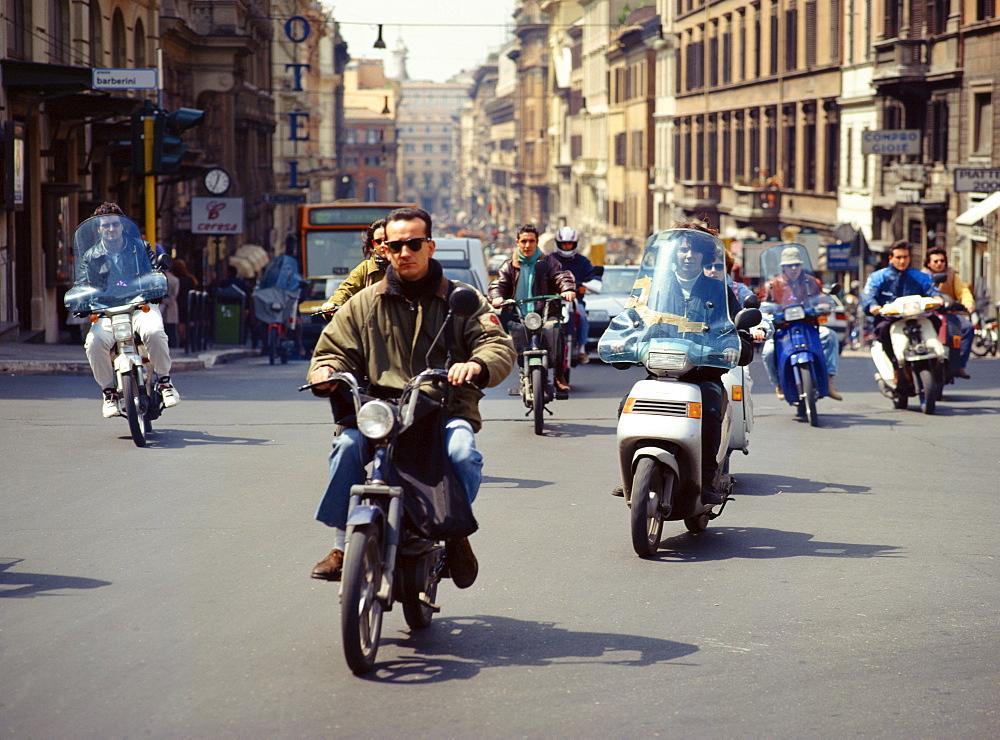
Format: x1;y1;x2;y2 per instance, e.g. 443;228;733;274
489;224;576;393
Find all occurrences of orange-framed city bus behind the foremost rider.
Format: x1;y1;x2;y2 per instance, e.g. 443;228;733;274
298;202;413;277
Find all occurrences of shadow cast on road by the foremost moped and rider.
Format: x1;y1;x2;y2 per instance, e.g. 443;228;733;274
366;615;698;684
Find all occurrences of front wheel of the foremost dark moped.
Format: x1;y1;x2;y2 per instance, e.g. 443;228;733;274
340;526;383;675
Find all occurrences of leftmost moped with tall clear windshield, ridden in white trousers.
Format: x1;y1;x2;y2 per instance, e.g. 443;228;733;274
64;215;167;447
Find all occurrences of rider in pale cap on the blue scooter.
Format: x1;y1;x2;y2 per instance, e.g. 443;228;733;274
760;247;844;401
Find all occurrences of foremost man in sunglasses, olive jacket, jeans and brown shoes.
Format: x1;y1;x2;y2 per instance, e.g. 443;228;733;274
308;208;516;588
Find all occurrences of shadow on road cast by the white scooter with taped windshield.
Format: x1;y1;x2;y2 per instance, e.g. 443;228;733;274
650;527;902;563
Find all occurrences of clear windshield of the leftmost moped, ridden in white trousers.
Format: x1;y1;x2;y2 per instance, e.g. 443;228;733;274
64;214;167;312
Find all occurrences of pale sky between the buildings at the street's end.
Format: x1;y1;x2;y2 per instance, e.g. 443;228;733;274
323;0;516;82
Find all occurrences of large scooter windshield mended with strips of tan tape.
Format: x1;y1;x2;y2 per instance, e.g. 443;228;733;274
598;229;740;369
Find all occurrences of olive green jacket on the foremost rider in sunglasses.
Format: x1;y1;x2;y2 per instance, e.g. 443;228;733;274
307;278;517;431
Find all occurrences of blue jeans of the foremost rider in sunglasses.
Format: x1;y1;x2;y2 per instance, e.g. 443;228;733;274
316;419;483;529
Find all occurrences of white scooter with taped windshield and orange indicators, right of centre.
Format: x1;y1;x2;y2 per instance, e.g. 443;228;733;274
598;229;761;557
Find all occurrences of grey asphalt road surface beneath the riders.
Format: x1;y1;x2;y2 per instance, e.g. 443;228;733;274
0;357;1000;738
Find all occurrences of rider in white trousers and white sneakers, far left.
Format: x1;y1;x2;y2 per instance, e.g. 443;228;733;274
76;202;181;419
